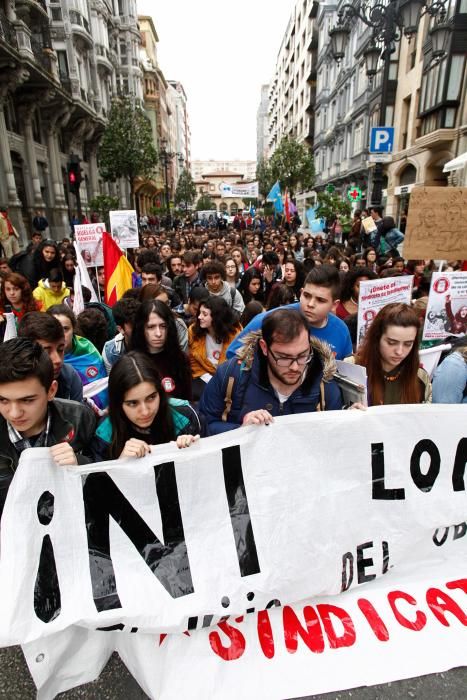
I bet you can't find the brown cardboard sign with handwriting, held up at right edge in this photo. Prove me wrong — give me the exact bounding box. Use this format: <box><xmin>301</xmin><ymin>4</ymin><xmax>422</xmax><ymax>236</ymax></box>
<box><xmin>402</xmin><ymin>187</ymin><xmax>467</xmax><ymax>260</ymax></box>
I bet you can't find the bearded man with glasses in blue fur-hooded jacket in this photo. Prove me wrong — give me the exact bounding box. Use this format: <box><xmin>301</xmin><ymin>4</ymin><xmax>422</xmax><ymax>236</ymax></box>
<box><xmin>199</xmin><ymin>308</ymin><xmax>342</xmax><ymax>435</ymax></box>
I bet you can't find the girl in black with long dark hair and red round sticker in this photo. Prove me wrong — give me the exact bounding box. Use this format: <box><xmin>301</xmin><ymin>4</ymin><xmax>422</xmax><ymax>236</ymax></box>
<box><xmin>130</xmin><ymin>300</ymin><xmax>191</xmax><ymax>401</ymax></box>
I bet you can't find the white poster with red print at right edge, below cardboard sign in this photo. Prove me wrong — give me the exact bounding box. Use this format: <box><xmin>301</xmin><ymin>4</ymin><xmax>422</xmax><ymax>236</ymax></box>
<box><xmin>423</xmin><ymin>272</ymin><xmax>467</xmax><ymax>340</ymax></box>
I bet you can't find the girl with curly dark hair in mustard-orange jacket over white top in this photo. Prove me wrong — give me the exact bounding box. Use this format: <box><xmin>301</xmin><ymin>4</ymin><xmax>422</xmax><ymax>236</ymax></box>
<box><xmin>188</xmin><ymin>296</ymin><xmax>243</xmax><ymax>400</ymax></box>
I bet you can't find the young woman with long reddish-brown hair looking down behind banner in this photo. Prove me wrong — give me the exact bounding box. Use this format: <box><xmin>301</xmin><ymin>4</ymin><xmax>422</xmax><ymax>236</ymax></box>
<box><xmin>351</xmin><ymin>303</ymin><xmax>431</xmax><ymax>406</ymax></box>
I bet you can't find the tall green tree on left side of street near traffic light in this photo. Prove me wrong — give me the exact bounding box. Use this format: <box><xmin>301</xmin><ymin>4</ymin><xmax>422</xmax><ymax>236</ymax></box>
<box><xmin>98</xmin><ymin>96</ymin><xmax>158</xmax><ymax>213</ymax></box>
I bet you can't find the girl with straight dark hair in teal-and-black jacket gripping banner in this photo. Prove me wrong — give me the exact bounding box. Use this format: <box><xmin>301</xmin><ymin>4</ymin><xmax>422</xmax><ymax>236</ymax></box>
<box><xmin>91</xmin><ymin>352</ymin><xmax>201</xmax><ymax>462</ymax></box>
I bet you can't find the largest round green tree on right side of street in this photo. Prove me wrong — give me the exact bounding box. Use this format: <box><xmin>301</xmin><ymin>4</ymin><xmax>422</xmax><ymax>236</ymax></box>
<box><xmin>269</xmin><ymin>136</ymin><xmax>315</xmax><ymax>196</ymax></box>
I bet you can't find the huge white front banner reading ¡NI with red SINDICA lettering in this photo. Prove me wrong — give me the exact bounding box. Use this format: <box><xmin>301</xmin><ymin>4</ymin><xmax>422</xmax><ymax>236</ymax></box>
<box><xmin>0</xmin><ymin>405</ymin><xmax>467</xmax><ymax>700</ymax></box>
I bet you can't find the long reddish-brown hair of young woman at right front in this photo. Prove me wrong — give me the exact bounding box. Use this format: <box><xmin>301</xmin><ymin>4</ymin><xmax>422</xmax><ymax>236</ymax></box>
<box><xmin>355</xmin><ymin>304</ymin><xmax>421</xmax><ymax>406</ymax></box>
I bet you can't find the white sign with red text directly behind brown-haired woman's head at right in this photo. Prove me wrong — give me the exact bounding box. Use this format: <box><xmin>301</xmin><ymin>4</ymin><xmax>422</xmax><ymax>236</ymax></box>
<box><xmin>357</xmin><ymin>275</ymin><xmax>413</xmax><ymax>345</ymax></box>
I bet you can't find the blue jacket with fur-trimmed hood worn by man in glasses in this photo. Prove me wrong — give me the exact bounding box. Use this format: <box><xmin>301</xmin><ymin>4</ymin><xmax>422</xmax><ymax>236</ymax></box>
<box><xmin>198</xmin><ymin>332</ymin><xmax>342</xmax><ymax>435</ymax></box>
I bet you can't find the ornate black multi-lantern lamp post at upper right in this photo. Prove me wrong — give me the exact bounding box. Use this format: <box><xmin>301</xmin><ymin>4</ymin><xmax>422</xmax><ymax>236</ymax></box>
<box><xmin>329</xmin><ymin>0</ymin><xmax>451</xmax><ymax>205</ymax></box>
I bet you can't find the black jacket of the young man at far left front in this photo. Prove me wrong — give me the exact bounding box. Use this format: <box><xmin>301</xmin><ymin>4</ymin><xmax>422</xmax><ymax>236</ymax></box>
<box><xmin>0</xmin><ymin>399</ymin><xmax>96</xmax><ymax>516</ymax></box>
